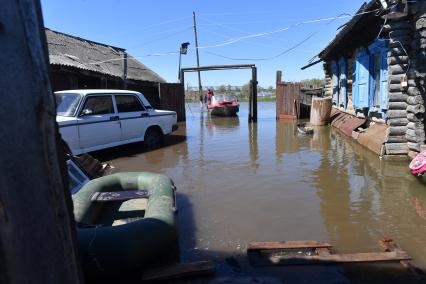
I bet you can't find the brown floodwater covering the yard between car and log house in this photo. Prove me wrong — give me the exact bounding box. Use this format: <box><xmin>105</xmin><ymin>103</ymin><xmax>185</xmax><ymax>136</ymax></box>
<box><xmin>95</xmin><ymin>103</ymin><xmax>426</xmax><ymax>283</ymax></box>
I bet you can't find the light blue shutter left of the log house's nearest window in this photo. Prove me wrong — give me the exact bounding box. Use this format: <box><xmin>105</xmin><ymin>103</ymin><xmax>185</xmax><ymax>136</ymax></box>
<box><xmin>357</xmin><ymin>49</ymin><xmax>370</xmax><ymax>108</ymax></box>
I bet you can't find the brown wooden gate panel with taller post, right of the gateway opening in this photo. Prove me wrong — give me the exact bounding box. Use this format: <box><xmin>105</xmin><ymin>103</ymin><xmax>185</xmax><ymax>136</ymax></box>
<box><xmin>276</xmin><ymin>71</ymin><xmax>300</xmax><ymax>119</ymax></box>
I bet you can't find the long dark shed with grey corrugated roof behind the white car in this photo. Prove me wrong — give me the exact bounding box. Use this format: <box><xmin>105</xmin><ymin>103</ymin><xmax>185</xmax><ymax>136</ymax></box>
<box><xmin>46</xmin><ymin>29</ymin><xmax>185</xmax><ymax>121</ymax></box>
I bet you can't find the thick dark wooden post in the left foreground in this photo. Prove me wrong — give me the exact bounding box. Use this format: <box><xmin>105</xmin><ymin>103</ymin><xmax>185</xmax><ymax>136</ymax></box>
<box><xmin>0</xmin><ymin>0</ymin><xmax>82</xmax><ymax>283</ymax></box>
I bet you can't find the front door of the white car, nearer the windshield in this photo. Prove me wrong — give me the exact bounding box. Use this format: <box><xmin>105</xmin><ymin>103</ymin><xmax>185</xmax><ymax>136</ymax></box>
<box><xmin>78</xmin><ymin>95</ymin><xmax>121</xmax><ymax>148</ymax></box>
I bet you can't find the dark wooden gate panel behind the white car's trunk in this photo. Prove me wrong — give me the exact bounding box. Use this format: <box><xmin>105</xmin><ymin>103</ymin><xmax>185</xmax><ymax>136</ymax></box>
<box><xmin>159</xmin><ymin>83</ymin><xmax>186</xmax><ymax>121</ymax></box>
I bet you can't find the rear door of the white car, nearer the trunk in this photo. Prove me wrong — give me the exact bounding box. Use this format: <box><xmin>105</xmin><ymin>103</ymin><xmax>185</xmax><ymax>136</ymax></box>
<box><xmin>115</xmin><ymin>94</ymin><xmax>149</xmax><ymax>141</ymax></box>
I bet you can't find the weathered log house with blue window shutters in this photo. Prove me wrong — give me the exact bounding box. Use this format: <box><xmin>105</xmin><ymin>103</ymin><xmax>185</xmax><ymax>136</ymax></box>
<box><xmin>304</xmin><ymin>0</ymin><xmax>426</xmax><ymax>155</ymax></box>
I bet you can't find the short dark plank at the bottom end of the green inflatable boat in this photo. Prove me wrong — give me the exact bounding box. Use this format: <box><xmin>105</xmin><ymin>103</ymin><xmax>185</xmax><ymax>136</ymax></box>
<box><xmin>142</xmin><ymin>261</ymin><xmax>215</xmax><ymax>281</ymax></box>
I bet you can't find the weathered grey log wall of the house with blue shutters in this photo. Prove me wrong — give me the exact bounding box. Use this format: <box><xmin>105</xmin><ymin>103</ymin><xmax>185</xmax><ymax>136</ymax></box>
<box><xmin>323</xmin><ymin>1</ymin><xmax>426</xmax><ymax>155</ymax></box>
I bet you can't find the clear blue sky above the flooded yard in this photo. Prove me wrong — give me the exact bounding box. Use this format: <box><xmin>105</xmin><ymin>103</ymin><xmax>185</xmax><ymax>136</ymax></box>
<box><xmin>41</xmin><ymin>0</ymin><xmax>364</xmax><ymax>87</ymax></box>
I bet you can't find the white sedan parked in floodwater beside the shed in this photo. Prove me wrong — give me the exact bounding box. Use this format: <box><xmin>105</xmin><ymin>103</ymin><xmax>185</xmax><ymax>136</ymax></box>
<box><xmin>55</xmin><ymin>90</ymin><xmax>177</xmax><ymax>155</ymax></box>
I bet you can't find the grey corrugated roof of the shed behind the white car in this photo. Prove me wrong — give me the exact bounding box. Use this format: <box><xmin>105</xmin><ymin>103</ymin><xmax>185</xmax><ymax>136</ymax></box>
<box><xmin>46</xmin><ymin>29</ymin><xmax>166</xmax><ymax>83</ymax></box>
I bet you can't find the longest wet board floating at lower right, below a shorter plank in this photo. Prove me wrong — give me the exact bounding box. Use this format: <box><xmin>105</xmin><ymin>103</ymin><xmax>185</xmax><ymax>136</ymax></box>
<box><xmin>250</xmin><ymin>251</ymin><xmax>411</xmax><ymax>266</ymax></box>
